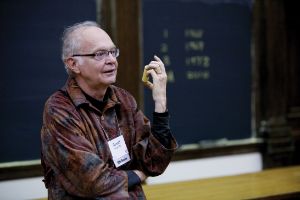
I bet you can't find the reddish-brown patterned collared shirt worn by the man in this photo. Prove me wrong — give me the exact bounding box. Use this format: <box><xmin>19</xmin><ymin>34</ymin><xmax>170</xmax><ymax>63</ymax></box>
<box><xmin>41</xmin><ymin>78</ymin><xmax>177</xmax><ymax>200</ymax></box>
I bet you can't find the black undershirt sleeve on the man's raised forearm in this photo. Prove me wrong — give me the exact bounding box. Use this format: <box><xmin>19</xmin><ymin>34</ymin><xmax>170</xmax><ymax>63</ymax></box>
<box><xmin>151</xmin><ymin>112</ymin><xmax>172</xmax><ymax>148</ymax></box>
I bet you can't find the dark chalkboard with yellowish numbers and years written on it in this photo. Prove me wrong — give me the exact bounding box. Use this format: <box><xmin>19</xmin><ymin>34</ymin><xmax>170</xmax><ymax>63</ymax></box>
<box><xmin>142</xmin><ymin>0</ymin><xmax>252</xmax><ymax>144</ymax></box>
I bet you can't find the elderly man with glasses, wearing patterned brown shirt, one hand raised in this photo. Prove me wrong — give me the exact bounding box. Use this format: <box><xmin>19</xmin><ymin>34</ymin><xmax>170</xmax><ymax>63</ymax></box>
<box><xmin>41</xmin><ymin>21</ymin><xmax>177</xmax><ymax>200</ymax></box>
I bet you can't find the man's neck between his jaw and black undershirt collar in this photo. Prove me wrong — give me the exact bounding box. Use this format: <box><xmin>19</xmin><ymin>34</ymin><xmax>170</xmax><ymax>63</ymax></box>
<box><xmin>75</xmin><ymin>78</ymin><xmax>108</xmax><ymax>101</ymax></box>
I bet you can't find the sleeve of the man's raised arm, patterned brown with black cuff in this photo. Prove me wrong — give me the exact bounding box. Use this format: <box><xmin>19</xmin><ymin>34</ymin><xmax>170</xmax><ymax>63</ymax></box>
<box><xmin>133</xmin><ymin>110</ymin><xmax>178</xmax><ymax>176</ymax></box>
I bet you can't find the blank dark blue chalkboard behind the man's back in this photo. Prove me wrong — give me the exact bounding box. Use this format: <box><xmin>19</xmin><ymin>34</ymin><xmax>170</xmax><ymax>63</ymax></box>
<box><xmin>0</xmin><ymin>0</ymin><xmax>96</xmax><ymax>162</ymax></box>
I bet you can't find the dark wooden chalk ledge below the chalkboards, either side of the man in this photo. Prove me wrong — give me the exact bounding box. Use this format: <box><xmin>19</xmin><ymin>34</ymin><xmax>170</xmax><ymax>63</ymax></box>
<box><xmin>0</xmin><ymin>138</ymin><xmax>263</xmax><ymax>181</ymax></box>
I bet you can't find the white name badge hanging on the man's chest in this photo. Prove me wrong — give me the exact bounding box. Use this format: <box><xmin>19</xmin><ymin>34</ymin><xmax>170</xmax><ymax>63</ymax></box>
<box><xmin>108</xmin><ymin>135</ymin><xmax>130</xmax><ymax>167</ymax></box>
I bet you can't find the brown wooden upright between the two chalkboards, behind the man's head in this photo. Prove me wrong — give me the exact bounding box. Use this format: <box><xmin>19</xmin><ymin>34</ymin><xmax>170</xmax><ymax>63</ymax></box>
<box><xmin>99</xmin><ymin>0</ymin><xmax>143</xmax><ymax>106</ymax></box>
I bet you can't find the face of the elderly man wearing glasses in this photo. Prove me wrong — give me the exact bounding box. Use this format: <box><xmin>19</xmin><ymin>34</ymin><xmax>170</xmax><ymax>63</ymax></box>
<box><xmin>69</xmin><ymin>27</ymin><xmax>118</xmax><ymax>89</ymax></box>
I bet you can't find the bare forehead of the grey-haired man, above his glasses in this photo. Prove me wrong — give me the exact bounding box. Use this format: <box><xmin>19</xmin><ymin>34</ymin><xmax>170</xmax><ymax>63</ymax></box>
<box><xmin>79</xmin><ymin>27</ymin><xmax>115</xmax><ymax>50</ymax></box>
